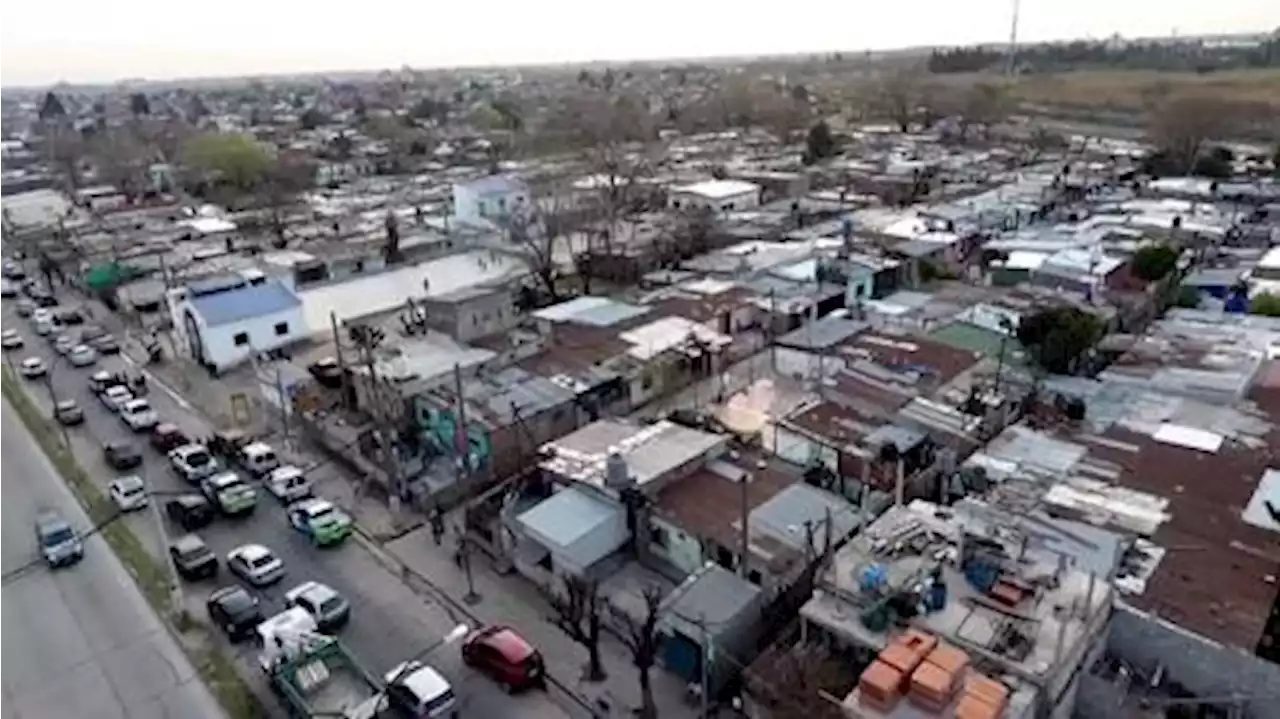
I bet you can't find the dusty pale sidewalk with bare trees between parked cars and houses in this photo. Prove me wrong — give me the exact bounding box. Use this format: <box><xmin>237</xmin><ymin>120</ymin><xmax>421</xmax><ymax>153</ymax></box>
<box><xmin>323</xmin><ymin>482</ymin><xmax>699</xmax><ymax>719</ymax></box>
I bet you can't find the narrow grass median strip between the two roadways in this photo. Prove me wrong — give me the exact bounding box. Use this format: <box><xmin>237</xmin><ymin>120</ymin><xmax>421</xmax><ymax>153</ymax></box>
<box><xmin>0</xmin><ymin>367</ymin><xmax>268</xmax><ymax>719</ymax></box>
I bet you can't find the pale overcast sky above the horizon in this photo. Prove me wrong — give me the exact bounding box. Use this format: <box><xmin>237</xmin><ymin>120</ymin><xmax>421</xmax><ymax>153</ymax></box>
<box><xmin>0</xmin><ymin>0</ymin><xmax>1280</xmax><ymax>86</ymax></box>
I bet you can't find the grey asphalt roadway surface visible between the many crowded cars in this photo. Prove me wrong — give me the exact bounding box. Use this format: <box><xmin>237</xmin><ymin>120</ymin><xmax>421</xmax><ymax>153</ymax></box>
<box><xmin>0</xmin><ymin>291</ymin><xmax>563</xmax><ymax>719</ymax></box>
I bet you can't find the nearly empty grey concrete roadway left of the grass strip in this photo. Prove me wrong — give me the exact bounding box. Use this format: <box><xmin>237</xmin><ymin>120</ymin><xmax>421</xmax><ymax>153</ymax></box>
<box><xmin>0</xmin><ymin>391</ymin><xmax>224</xmax><ymax>719</ymax></box>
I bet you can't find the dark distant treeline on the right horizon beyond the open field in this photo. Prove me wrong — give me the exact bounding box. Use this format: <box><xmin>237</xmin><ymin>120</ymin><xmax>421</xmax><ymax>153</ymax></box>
<box><xmin>929</xmin><ymin>37</ymin><xmax>1280</xmax><ymax>73</ymax></box>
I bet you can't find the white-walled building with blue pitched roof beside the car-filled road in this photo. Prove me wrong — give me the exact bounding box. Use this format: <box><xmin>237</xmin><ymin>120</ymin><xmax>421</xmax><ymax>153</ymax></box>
<box><xmin>166</xmin><ymin>273</ymin><xmax>311</xmax><ymax>372</ymax></box>
